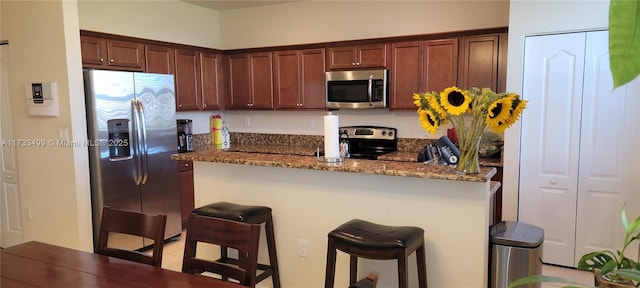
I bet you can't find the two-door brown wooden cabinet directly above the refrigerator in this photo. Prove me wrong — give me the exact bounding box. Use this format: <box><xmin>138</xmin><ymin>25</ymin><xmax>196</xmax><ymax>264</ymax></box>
<box><xmin>80</xmin><ymin>36</ymin><xmax>145</xmax><ymax>71</ymax></box>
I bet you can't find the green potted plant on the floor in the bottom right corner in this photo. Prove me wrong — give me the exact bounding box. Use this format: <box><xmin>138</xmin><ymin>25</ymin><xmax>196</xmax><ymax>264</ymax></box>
<box><xmin>509</xmin><ymin>208</ymin><xmax>640</xmax><ymax>288</ymax></box>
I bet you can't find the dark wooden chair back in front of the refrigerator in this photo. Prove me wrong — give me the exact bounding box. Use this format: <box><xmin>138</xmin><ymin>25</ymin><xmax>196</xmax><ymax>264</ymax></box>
<box><xmin>96</xmin><ymin>207</ymin><xmax>167</xmax><ymax>267</ymax></box>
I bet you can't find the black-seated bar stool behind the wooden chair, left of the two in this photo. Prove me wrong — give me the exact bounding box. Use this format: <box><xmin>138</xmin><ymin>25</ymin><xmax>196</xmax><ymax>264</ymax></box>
<box><xmin>191</xmin><ymin>202</ymin><xmax>280</xmax><ymax>288</ymax></box>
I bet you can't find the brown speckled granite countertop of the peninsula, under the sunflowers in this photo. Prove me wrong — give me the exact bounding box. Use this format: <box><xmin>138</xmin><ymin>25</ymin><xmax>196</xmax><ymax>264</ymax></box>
<box><xmin>171</xmin><ymin>145</ymin><xmax>497</xmax><ymax>182</ymax></box>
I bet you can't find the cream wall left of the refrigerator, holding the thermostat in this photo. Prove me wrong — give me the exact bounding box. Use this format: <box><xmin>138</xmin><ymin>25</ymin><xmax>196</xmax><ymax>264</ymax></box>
<box><xmin>0</xmin><ymin>1</ymin><xmax>93</xmax><ymax>250</ymax></box>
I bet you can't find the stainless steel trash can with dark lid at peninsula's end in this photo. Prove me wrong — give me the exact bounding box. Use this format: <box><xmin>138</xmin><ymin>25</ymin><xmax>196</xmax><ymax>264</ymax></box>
<box><xmin>489</xmin><ymin>221</ymin><xmax>544</xmax><ymax>288</ymax></box>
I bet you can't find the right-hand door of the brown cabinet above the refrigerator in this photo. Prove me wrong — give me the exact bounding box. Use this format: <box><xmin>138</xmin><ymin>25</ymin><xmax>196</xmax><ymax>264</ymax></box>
<box><xmin>107</xmin><ymin>40</ymin><xmax>145</xmax><ymax>71</ymax></box>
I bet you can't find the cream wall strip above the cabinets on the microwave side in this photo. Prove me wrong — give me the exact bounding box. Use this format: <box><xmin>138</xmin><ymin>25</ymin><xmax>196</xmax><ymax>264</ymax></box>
<box><xmin>220</xmin><ymin>0</ymin><xmax>509</xmax><ymax>49</ymax></box>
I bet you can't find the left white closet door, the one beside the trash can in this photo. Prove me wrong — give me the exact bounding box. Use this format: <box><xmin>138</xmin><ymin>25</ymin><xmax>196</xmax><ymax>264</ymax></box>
<box><xmin>518</xmin><ymin>33</ymin><xmax>585</xmax><ymax>266</ymax></box>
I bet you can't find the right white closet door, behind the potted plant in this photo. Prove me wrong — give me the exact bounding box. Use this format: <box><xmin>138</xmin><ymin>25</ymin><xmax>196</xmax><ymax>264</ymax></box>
<box><xmin>576</xmin><ymin>31</ymin><xmax>640</xmax><ymax>263</ymax></box>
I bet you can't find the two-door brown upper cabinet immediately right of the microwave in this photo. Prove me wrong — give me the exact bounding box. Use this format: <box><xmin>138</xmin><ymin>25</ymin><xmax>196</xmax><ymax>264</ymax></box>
<box><xmin>389</xmin><ymin>39</ymin><xmax>458</xmax><ymax>109</ymax></box>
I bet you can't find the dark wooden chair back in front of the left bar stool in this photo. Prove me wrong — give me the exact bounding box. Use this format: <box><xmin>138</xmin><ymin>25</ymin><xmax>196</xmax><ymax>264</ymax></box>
<box><xmin>182</xmin><ymin>213</ymin><xmax>260</xmax><ymax>287</ymax></box>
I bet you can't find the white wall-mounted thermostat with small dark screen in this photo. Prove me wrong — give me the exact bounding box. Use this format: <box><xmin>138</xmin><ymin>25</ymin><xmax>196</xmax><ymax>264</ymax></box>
<box><xmin>25</xmin><ymin>82</ymin><xmax>60</xmax><ymax>117</ymax></box>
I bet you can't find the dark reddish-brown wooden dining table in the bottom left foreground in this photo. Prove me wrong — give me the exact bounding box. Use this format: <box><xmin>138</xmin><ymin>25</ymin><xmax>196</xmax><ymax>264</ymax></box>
<box><xmin>0</xmin><ymin>241</ymin><xmax>246</xmax><ymax>288</ymax></box>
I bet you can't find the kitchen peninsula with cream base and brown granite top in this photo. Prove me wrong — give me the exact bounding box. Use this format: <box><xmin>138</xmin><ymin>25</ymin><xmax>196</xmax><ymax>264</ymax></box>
<box><xmin>173</xmin><ymin>147</ymin><xmax>499</xmax><ymax>287</ymax></box>
